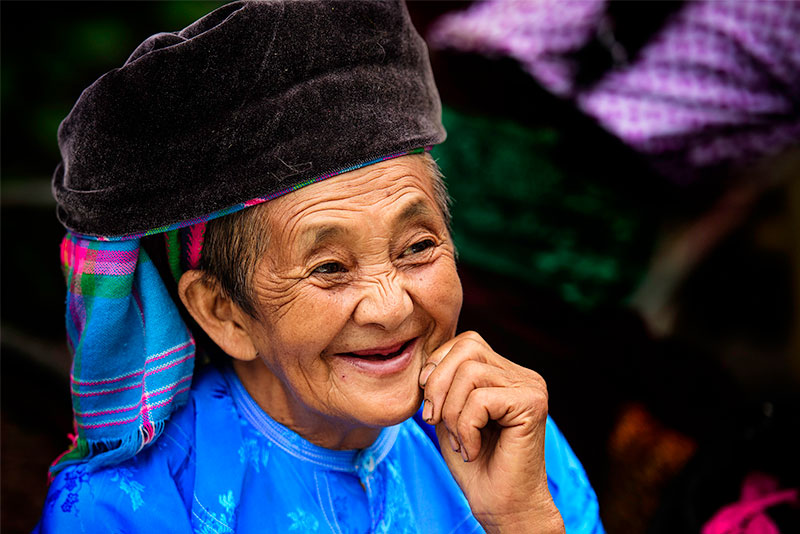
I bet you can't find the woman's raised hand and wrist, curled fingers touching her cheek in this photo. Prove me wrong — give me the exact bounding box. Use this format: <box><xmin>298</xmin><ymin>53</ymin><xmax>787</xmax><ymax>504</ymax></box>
<box><xmin>420</xmin><ymin>332</ymin><xmax>564</xmax><ymax>534</ymax></box>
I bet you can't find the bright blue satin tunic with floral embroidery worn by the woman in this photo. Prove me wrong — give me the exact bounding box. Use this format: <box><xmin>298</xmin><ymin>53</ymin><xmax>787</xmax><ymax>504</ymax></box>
<box><xmin>34</xmin><ymin>368</ymin><xmax>604</xmax><ymax>534</ymax></box>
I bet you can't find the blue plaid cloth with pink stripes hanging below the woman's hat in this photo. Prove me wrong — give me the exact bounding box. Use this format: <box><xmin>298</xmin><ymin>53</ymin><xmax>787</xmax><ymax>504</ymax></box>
<box><xmin>51</xmin><ymin>234</ymin><xmax>195</xmax><ymax>473</ymax></box>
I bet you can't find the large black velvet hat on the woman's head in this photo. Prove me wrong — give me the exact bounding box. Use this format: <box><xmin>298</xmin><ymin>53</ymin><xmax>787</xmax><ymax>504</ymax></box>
<box><xmin>53</xmin><ymin>0</ymin><xmax>445</xmax><ymax>237</ymax></box>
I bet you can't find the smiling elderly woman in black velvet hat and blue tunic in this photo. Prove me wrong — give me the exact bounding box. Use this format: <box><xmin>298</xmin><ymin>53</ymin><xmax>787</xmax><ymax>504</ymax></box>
<box><xmin>37</xmin><ymin>1</ymin><xmax>602</xmax><ymax>533</ymax></box>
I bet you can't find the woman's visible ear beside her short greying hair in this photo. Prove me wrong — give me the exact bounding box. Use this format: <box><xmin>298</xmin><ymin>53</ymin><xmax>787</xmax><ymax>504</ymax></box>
<box><xmin>178</xmin><ymin>270</ymin><xmax>258</xmax><ymax>361</ymax></box>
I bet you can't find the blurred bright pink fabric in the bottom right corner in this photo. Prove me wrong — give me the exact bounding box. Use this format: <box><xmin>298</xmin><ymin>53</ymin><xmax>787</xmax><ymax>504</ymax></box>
<box><xmin>702</xmin><ymin>472</ymin><xmax>800</xmax><ymax>534</ymax></box>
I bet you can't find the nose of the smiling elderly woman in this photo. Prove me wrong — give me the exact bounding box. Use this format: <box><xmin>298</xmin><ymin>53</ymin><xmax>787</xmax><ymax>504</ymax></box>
<box><xmin>353</xmin><ymin>271</ymin><xmax>414</xmax><ymax>331</ymax></box>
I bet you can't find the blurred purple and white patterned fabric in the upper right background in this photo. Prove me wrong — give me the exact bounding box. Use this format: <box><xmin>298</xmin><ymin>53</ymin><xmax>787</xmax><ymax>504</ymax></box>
<box><xmin>430</xmin><ymin>0</ymin><xmax>800</xmax><ymax>182</ymax></box>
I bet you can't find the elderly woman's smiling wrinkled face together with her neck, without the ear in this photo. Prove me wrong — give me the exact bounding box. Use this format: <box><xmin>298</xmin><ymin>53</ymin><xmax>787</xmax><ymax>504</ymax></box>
<box><xmin>237</xmin><ymin>156</ymin><xmax>461</xmax><ymax>448</ymax></box>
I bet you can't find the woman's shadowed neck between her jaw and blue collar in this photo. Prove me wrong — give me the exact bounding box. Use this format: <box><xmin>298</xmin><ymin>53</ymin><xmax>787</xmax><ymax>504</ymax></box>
<box><xmin>233</xmin><ymin>359</ymin><xmax>382</xmax><ymax>450</ymax></box>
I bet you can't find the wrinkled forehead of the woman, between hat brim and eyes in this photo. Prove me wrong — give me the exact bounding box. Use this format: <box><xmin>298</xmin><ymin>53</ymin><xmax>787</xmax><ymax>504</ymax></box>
<box><xmin>266</xmin><ymin>155</ymin><xmax>443</xmax><ymax>237</ymax></box>
